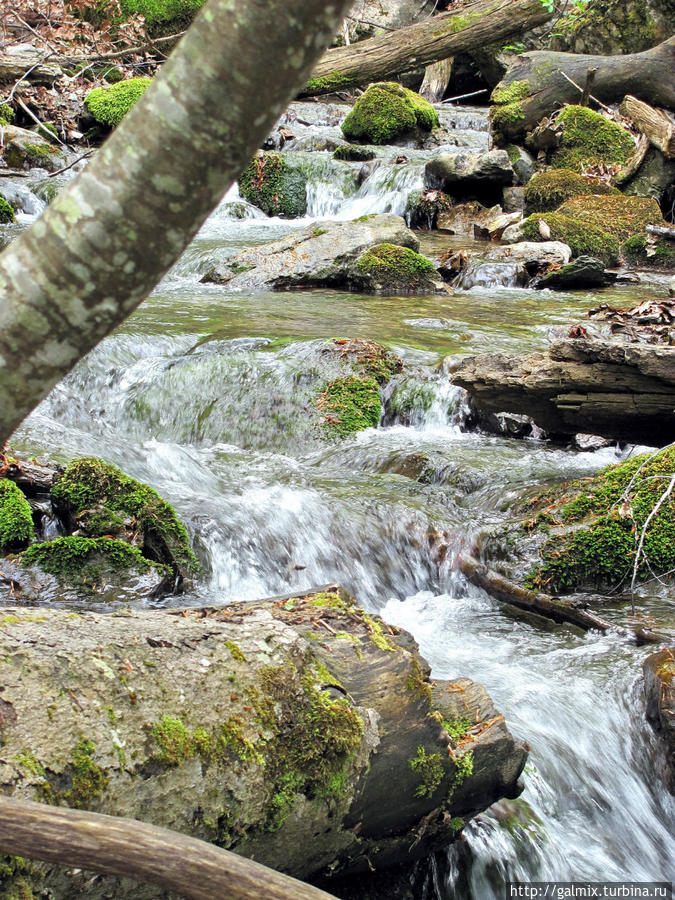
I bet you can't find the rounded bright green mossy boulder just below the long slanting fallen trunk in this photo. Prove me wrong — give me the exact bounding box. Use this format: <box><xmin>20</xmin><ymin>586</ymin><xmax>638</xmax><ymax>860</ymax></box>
<box><xmin>342</xmin><ymin>81</ymin><xmax>438</xmax><ymax>144</ymax></box>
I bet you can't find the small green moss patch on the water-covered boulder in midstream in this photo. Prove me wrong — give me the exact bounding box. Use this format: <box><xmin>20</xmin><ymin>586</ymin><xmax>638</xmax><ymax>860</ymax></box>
<box><xmin>316</xmin><ymin>375</ymin><xmax>382</xmax><ymax>437</ymax></box>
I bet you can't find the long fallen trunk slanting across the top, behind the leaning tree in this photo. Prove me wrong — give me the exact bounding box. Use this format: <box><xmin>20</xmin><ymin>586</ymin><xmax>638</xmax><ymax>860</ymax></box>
<box><xmin>301</xmin><ymin>0</ymin><xmax>551</xmax><ymax>96</ymax></box>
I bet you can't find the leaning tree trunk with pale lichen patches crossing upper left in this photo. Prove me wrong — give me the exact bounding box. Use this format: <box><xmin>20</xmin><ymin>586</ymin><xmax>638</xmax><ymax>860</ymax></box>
<box><xmin>0</xmin><ymin>0</ymin><xmax>349</xmax><ymax>442</ymax></box>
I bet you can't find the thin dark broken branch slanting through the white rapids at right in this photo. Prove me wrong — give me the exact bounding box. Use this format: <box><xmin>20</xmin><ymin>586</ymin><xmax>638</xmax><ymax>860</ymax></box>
<box><xmin>457</xmin><ymin>554</ymin><xmax>662</xmax><ymax>644</ymax></box>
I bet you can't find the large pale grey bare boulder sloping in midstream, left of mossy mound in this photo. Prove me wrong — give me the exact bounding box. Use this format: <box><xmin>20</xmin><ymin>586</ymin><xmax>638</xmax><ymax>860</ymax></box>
<box><xmin>202</xmin><ymin>213</ymin><xmax>419</xmax><ymax>291</ymax></box>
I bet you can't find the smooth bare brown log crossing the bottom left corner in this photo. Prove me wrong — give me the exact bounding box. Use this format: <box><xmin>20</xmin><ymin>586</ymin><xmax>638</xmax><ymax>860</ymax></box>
<box><xmin>0</xmin><ymin>796</ymin><xmax>335</xmax><ymax>900</ymax></box>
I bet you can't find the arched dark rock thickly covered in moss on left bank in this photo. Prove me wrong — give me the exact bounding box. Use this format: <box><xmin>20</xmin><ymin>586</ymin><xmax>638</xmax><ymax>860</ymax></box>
<box><xmin>51</xmin><ymin>458</ymin><xmax>197</xmax><ymax>576</ymax></box>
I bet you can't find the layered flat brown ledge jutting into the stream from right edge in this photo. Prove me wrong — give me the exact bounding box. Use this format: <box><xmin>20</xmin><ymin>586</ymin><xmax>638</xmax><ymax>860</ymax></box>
<box><xmin>449</xmin><ymin>340</ymin><xmax>675</xmax><ymax>447</ymax></box>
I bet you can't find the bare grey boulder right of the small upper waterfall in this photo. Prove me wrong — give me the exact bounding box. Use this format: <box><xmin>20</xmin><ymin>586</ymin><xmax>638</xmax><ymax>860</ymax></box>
<box><xmin>424</xmin><ymin>150</ymin><xmax>515</xmax><ymax>194</ymax></box>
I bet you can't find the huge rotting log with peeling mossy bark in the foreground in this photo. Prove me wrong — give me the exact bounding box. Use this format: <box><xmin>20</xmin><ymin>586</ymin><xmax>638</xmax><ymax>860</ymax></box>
<box><xmin>0</xmin><ymin>585</ymin><xmax>527</xmax><ymax>900</ymax></box>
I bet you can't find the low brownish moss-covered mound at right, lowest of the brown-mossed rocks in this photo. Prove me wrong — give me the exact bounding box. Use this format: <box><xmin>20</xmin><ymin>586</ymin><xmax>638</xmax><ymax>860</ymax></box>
<box><xmin>558</xmin><ymin>193</ymin><xmax>668</xmax><ymax>241</ymax></box>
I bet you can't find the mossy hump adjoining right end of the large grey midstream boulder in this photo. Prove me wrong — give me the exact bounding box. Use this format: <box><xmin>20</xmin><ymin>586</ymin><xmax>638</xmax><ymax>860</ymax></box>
<box><xmin>354</xmin><ymin>244</ymin><xmax>438</xmax><ymax>293</ymax></box>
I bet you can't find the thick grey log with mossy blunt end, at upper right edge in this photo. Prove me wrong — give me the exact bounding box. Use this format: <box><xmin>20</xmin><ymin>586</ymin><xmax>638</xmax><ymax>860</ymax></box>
<box><xmin>491</xmin><ymin>37</ymin><xmax>675</xmax><ymax>146</ymax></box>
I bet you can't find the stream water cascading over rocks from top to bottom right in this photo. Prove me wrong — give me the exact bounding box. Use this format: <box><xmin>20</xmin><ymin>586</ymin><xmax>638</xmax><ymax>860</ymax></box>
<box><xmin>5</xmin><ymin>103</ymin><xmax>675</xmax><ymax>900</ymax></box>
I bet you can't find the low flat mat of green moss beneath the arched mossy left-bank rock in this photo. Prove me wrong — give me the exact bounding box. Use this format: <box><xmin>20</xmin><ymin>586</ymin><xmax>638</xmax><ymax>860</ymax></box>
<box><xmin>21</xmin><ymin>537</ymin><xmax>169</xmax><ymax>590</ymax></box>
